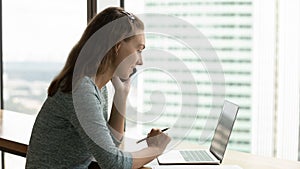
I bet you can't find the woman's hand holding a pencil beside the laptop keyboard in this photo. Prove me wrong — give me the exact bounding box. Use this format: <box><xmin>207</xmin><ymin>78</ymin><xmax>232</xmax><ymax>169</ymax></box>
<box><xmin>147</xmin><ymin>129</ymin><xmax>171</xmax><ymax>154</ymax></box>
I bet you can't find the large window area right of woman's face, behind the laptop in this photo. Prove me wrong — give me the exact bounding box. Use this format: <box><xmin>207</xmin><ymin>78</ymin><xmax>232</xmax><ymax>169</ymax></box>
<box><xmin>125</xmin><ymin>0</ymin><xmax>300</xmax><ymax>160</ymax></box>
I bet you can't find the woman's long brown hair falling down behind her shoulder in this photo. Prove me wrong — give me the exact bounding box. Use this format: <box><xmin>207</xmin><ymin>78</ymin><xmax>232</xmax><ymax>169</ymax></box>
<box><xmin>48</xmin><ymin>7</ymin><xmax>144</xmax><ymax>96</ymax></box>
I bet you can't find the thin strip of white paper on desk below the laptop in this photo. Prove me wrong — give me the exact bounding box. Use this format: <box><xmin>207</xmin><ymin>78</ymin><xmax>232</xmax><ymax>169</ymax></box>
<box><xmin>152</xmin><ymin>165</ymin><xmax>242</xmax><ymax>169</ymax></box>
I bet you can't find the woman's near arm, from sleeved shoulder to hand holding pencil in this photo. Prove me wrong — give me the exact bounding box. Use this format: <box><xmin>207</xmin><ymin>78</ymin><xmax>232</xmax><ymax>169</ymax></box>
<box><xmin>70</xmin><ymin>78</ymin><xmax>170</xmax><ymax>169</ymax></box>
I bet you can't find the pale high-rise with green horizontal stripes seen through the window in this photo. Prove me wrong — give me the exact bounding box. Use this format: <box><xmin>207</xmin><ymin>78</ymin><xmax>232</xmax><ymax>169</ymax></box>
<box><xmin>125</xmin><ymin>0</ymin><xmax>253</xmax><ymax>152</ymax></box>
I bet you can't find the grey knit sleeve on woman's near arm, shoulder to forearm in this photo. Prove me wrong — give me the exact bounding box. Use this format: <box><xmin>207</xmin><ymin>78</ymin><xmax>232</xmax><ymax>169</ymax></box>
<box><xmin>71</xmin><ymin>78</ymin><xmax>132</xmax><ymax>169</ymax></box>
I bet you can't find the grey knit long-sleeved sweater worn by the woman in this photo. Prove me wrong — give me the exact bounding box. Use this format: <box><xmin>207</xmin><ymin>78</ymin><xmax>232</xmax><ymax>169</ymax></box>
<box><xmin>26</xmin><ymin>77</ymin><xmax>132</xmax><ymax>169</ymax></box>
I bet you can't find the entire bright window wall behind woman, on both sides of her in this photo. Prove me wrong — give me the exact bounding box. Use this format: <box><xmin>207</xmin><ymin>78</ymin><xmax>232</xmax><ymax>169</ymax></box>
<box><xmin>2</xmin><ymin>0</ymin><xmax>300</xmax><ymax>166</ymax></box>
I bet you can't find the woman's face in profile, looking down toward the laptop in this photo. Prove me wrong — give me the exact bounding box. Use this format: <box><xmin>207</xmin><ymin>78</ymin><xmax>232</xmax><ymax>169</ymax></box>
<box><xmin>114</xmin><ymin>34</ymin><xmax>145</xmax><ymax>79</ymax></box>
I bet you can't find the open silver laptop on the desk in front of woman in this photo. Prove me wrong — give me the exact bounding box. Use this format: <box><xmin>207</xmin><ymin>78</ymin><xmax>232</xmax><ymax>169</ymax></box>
<box><xmin>157</xmin><ymin>100</ymin><xmax>239</xmax><ymax>165</ymax></box>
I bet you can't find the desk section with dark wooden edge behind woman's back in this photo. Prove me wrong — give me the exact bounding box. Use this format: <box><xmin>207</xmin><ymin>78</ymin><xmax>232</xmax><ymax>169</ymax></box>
<box><xmin>0</xmin><ymin>110</ymin><xmax>36</xmax><ymax>168</ymax></box>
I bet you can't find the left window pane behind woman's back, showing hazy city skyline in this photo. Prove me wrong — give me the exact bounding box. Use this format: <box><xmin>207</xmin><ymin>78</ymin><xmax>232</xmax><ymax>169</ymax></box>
<box><xmin>2</xmin><ymin>0</ymin><xmax>87</xmax><ymax>114</ymax></box>
